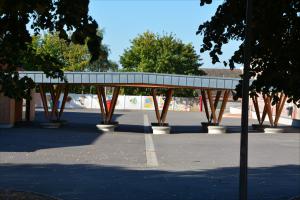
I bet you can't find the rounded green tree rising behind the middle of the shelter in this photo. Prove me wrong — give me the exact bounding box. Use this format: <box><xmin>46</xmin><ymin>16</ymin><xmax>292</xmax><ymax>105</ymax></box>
<box><xmin>120</xmin><ymin>32</ymin><xmax>205</xmax><ymax>96</ymax></box>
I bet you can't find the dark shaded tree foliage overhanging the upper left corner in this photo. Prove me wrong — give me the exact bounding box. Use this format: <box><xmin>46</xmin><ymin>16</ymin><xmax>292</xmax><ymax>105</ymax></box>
<box><xmin>0</xmin><ymin>0</ymin><xmax>102</xmax><ymax>98</ymax></box>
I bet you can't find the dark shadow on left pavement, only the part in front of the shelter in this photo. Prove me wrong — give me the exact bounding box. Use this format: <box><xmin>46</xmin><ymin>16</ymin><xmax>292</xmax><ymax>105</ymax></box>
<box><xmin>0</xmin><ymin>127</ymin><xmax>101</xmax><ymax>152</ymax></box>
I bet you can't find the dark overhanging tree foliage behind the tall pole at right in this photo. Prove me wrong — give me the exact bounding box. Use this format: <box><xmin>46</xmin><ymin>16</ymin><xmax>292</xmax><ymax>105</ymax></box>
<box><xmin>197</xmin><ymin>0</ymin><xmax>300</xmax><ymax>106</ymax></box>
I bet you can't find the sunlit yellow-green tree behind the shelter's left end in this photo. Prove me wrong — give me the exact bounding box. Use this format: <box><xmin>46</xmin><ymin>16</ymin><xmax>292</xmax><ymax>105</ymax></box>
<box><xmin>24</xmin><ymin>31</ymin><xmax>118</xmax><ymax>71</ymax></box>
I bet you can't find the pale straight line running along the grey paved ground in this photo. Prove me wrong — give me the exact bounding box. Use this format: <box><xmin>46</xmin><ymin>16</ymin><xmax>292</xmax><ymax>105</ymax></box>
<box><xmin>144</xmin><ymin>114</ymin><xmax>158</xmax><ymax>167</ymax></box>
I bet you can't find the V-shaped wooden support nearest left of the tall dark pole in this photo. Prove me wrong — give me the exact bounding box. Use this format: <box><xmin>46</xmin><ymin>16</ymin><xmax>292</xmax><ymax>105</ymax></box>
<box><xmin>201</xmin><ymin>90</ymin><xmax>230</xmax><ymax>124</ymax></box>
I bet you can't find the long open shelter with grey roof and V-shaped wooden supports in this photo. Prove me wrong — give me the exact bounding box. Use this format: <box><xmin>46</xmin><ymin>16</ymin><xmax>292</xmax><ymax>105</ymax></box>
<box><xmin>20</xmin><ymin>71</ymin><xmax>240</xmax><ymax>130</ymax></box>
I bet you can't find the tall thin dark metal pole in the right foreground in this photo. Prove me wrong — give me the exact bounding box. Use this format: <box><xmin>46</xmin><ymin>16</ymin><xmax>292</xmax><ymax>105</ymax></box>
<box><xmin>239</xmin><ymin>0</ymin><xmax>252</xmax><ymax>200</ymax></box>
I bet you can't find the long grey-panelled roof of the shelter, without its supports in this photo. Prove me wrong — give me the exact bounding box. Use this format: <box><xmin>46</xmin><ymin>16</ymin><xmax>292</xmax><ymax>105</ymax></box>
<box><xmin>19</xmin><ymin>71</ymin><xmax>240</xmax><ymax>90</ymax></box>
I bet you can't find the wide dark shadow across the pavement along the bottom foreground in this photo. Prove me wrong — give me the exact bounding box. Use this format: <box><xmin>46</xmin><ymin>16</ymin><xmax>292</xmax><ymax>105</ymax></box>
<box><xmin>0</xmin><ymin>164</ymin><xmax>300</xmax><ymax>200</ymax></box>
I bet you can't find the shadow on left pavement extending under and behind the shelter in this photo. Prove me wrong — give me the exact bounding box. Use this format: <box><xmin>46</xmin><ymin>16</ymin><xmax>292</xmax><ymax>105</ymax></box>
<box><xmin>0</xmin><ymin>112</ymin><xmax>125</xmax><ymax>152</ymax></box>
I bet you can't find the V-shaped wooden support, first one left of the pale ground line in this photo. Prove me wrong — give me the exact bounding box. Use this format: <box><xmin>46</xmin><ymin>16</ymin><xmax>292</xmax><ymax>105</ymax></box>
<box><xmin>96</xmin><ymin>86</ymin><xmax>120</xmax><ymax>124</ymax></box>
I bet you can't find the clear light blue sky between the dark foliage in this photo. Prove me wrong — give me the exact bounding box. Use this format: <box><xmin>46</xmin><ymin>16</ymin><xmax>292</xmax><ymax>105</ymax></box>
<box><xmin>89</xmin><ymin>0</ymin><xmax>238</xmax><ymax>68</ymax></box>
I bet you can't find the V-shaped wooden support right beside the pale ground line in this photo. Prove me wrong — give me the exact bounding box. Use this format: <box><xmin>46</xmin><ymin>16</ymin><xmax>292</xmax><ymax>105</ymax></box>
<box><xmin>151</xmin><ymin>88</ymin><xmax>174</xmax><ymax>125</ymax></box>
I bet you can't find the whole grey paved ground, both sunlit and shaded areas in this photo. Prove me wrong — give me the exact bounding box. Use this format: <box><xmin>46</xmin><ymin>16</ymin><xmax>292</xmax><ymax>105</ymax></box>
<box><xmin>0</xmin><ymin>111</ymin><xmax>300</xmax><ymax>200</ymax></box>
